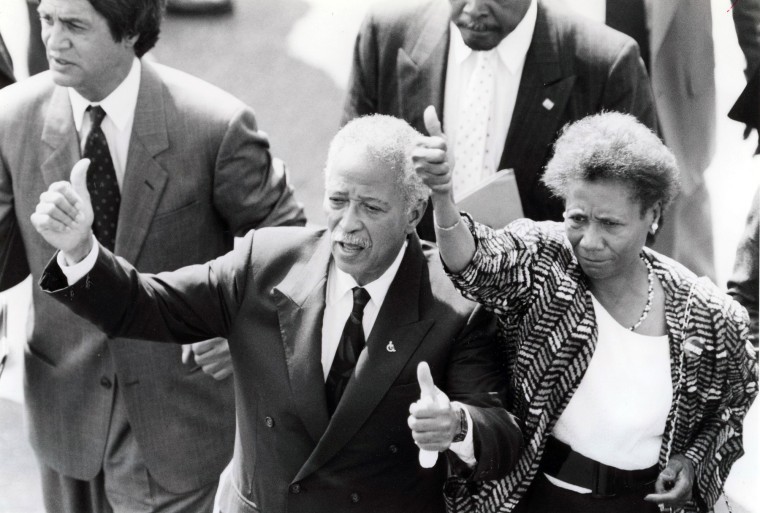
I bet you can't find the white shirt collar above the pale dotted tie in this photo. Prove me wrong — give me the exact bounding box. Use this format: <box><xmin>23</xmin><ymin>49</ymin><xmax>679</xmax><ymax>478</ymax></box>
<box><xmin>449</xmin><ymin>0</ymin><xmax>538</xmax><ymax>74</ymax></box>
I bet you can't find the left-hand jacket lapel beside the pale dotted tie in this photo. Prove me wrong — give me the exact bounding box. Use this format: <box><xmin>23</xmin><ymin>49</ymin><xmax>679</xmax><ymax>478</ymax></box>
<box><xmin>396</xmin><ymin>2</ymin><xmax>449</xmax><ymax>131</ymax></box>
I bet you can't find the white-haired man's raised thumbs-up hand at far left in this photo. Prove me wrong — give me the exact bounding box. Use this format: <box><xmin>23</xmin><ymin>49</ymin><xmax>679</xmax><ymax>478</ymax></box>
<box><xmin>30</xmin><ymin>159</ymin><xmax>93</xmax><ymax>264</ymax></box>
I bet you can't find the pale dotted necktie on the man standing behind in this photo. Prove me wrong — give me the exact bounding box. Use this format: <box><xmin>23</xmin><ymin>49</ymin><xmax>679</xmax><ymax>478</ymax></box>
<box><xmin>453</xmin><ymin>50</ymin><xmax>497</xmax><ymax>196</ymax></box>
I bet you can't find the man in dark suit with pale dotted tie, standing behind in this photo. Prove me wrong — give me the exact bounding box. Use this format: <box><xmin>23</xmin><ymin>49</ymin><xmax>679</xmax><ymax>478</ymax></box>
<box><xmin>343</xmin><ymin>0</ymin><xmax>656</xmax><ymax>238</ymax></box>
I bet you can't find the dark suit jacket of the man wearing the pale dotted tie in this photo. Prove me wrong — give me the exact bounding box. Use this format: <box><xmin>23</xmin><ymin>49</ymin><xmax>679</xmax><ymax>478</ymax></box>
<box><xmin>343</xmin><ymin>0</ymin><xmax>656</xmax><ymax>238</ymax></box>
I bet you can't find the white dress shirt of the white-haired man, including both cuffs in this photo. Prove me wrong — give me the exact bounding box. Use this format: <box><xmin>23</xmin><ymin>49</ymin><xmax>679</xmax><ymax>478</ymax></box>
<box><xmin>56</xmin><ymin>235</ymin><xmax>477</xmax><ymax>468</ymax></box>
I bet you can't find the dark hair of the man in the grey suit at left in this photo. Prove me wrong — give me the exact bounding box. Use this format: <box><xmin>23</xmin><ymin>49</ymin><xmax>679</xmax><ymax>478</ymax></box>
<box><xmin>88</xmin><ymin>0</ymin><xmax>166</xmax><ymax>57</ymax></box>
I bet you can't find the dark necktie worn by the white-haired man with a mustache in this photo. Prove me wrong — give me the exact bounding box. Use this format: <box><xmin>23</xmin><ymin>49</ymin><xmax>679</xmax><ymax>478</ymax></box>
<box><xmin>325</xmin><ymin>287</ymin><xmax>370</xmax><ymax>417</ymax></box>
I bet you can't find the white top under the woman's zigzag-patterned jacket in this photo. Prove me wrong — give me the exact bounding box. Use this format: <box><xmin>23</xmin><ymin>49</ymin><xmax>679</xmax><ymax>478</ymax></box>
<box><xmin>547</xmin><ymin>296</ymin><xmax>673</xmax><ymax>493</ymax></box>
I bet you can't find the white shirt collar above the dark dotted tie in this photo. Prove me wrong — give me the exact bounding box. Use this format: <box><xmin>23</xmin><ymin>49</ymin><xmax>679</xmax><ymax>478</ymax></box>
<box><xmin>68</xmin><ymin>57</ymin><xmax>142</xmax><ymax>132</ymax></box>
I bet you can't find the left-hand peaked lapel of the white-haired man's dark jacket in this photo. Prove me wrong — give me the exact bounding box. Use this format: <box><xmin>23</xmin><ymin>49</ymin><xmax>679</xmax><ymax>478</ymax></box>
<box><xmin>273</xmin><ymin>232</ymin><xmax>330</xmax><ymax>444</ymax></box>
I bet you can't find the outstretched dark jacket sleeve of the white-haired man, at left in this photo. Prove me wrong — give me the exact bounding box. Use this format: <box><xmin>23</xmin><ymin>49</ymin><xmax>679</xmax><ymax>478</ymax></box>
<box><xmin>40</xmin><ymin>232</ymin><xmax>254</xmax><ymax>343</ymax></box>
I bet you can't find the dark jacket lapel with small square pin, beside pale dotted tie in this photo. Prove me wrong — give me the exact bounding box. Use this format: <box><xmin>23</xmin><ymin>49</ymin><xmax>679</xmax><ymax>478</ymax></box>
<box><xmin>499</xmin><ymin>3</ymin><xmax>575</xmax><ymax>191</ymax></box>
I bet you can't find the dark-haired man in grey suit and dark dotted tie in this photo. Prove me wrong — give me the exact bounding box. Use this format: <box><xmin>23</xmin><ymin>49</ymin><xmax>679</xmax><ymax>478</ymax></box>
<box><xmin>0</xmin><ymin>0</ymin><xmax>304</xmax><ymax>513</ymax></box>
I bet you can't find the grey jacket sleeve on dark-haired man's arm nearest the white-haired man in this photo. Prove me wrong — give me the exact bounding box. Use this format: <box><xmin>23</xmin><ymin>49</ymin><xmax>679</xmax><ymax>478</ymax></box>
<box><xmin>214</xmin><ymin>107</ymin><xmax>306</xmax><ymax>236</ymax></box>
